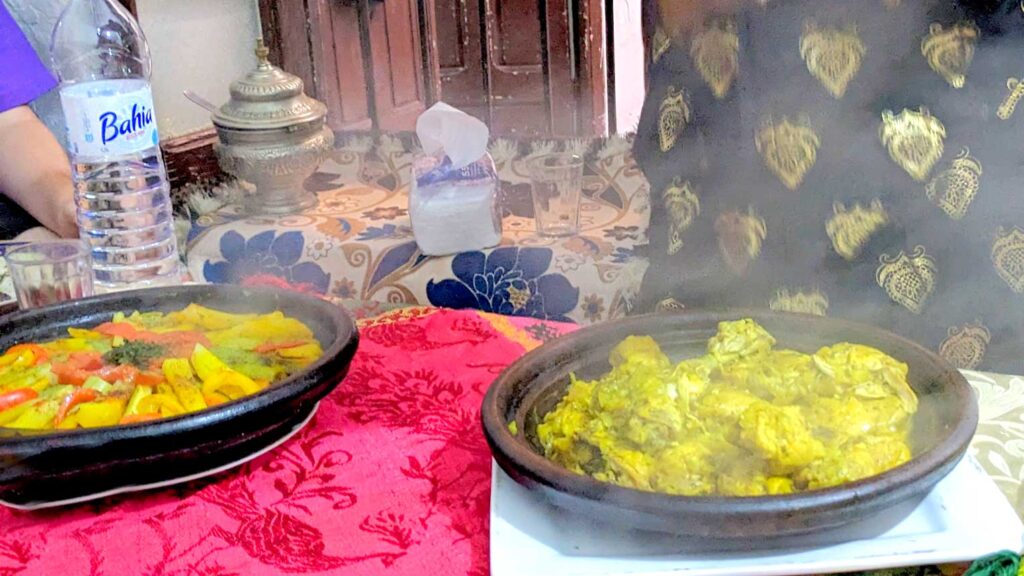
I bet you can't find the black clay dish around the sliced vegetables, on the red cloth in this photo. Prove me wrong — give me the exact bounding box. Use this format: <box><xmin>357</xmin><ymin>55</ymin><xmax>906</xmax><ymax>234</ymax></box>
<box><xmin>0</xmin><ymin>285</ymin><xmax>358</xmax><ymax>508</ymax></box>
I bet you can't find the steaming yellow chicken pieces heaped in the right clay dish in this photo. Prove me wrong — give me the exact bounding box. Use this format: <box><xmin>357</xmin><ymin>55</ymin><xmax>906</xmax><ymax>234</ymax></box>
<box><xmin>537</xmin><ymin>320</ymin><xmax>918</xmax><ymax>496</ymax></box>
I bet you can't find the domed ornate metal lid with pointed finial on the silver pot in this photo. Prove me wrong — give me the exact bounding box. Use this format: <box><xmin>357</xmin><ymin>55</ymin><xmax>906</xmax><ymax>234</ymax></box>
<box><xmin>213</xmin><ymin>39</ymin><xmax>327</xmax><ymax>130</ymax></box>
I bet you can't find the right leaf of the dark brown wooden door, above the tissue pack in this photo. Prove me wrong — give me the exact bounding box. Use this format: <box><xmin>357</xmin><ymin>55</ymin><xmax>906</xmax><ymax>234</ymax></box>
<box><xmin>435</xmin><ymin>0</ymin><xmax>605</xmax><ymax>136</ymax></box>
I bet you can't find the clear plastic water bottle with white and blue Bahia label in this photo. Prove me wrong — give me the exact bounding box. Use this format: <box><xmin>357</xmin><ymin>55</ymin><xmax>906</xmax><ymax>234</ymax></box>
<box><xmin>50</xmin><ymin>0</ymin><xmax>181</xmax><ymax>291</ymax></box>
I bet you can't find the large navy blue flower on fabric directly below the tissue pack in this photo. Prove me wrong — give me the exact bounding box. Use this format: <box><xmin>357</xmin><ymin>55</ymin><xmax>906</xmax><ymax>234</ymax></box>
<box><xmin>427</xmin><ymin>243</ymin><xmax>580</xmax><ymax>322</ymax></box>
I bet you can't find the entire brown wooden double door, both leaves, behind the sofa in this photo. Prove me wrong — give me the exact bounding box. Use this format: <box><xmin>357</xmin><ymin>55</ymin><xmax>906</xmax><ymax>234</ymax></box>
<box><xmin>259</xmin><ymin>0</ymin><xmax>607</xmax><ymax>136</ymax></box>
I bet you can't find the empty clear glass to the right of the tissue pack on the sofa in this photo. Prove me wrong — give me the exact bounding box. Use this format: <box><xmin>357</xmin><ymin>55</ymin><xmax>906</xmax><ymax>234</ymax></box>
<box><xmin>527</xmin><ymin>154</ymin><xmax>583</xmax><ymax>237</ymax></box>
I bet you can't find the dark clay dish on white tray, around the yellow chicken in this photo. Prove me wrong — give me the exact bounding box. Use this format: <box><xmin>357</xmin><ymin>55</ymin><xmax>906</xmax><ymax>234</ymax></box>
<box><xmin>482</xmin><ymin>311</ymin><xmax>978</xmax><ymax>537</ymax></box>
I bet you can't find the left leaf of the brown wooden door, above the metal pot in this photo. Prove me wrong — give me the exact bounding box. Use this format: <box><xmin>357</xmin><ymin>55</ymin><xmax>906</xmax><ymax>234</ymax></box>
<box><xmin>260</xmin><ymin>0</ymin><xmax>436</xmax><ymax>131</ymax></box>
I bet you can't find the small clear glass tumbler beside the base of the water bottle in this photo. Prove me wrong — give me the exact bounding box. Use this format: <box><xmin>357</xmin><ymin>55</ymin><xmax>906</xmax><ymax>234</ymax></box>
<box><xmin>4</xmin><ymin>240</ymin><xmax>93</xmax><ymax>310</ymax></box>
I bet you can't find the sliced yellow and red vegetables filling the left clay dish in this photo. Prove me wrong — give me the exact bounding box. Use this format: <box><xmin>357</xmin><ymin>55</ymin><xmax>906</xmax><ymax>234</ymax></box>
<box><xmin>0</xmin><ymin>304</ymin><xmax>323</xmax><ymax>430</ymax></box>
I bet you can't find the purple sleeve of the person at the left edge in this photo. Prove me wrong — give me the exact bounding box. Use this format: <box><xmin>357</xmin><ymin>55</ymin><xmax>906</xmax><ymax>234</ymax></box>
<box><xmin>0</xmin><ymin>2</ymin><xmax>56</xmax><ymax>112</ymax></box>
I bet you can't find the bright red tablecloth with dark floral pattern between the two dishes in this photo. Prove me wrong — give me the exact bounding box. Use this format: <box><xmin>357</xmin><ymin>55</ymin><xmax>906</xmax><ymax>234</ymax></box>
<box><xmin>0</xmin><ymin>308</ymin><xmax>571</xmax><ymax>576</ymax></box>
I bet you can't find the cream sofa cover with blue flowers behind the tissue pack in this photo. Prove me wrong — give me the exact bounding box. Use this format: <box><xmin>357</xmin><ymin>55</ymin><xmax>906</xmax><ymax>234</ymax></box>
<box><xmin>187</xmin><ymin>132</ymin><xmax>650</xmax><ymax>323</ymax></box>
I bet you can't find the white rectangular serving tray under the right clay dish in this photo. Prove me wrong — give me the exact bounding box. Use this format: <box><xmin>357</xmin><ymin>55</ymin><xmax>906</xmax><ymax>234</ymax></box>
<box><xmin>490</xmin><ymin>457</ymin><xmax>1024</xmax><ymax>576</ymax></box>
